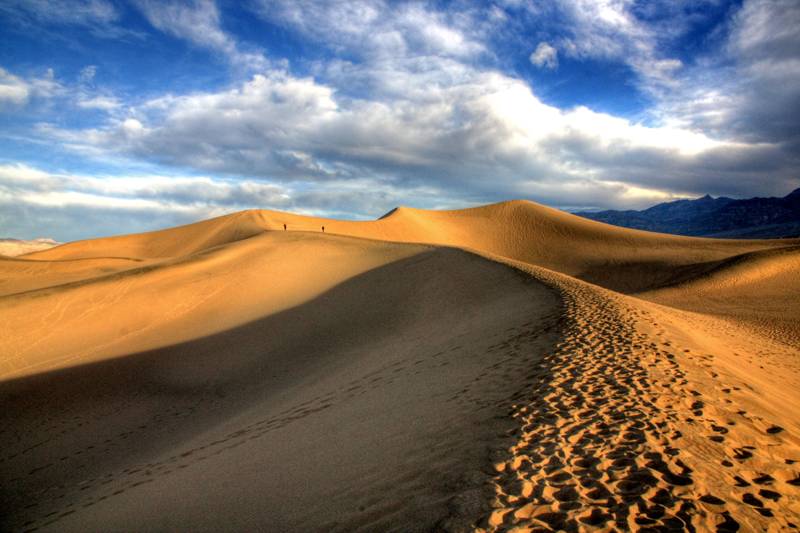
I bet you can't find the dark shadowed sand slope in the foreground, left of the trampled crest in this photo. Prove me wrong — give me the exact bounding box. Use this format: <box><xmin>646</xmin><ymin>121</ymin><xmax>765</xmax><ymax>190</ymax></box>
<box><xmin>0</xmin><ymin>243</ymin><xmax>559</xmax><ymax>531</ymax></box>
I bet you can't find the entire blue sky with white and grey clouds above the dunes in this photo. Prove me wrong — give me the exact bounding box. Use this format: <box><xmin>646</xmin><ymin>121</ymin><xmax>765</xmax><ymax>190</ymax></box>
<box><xmin>0</xmin><ymin>0</ymin><xmax>800</xmax><ymax>241</ymax></box>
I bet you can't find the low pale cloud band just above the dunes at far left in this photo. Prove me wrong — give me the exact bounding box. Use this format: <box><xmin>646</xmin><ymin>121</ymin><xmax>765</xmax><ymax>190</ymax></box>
<box><xmin>0</xmin><ymin>163</ymin><xmax>287</xmax><ymax>240</ymax></box>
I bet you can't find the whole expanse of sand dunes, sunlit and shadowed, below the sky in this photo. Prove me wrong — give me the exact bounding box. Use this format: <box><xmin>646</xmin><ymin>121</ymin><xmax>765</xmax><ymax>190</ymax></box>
<box><xmin>0</xmin><ymin>201</ymin><xmax>800</xmax><ymax>532</ymax></box>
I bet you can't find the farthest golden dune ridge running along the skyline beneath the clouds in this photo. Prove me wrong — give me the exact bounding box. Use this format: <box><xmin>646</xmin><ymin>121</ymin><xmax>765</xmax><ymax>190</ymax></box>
<box><xmin>27</xmin><ymin>201</ymin><xmax>800</xmax><ymax>292</ymax></box>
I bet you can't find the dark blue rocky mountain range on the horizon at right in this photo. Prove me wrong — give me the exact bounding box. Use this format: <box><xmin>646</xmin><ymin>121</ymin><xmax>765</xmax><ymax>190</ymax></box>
<box><xmin>575</xmin><ymin>189</ymin><xmax>800</xmax><ymax>239</ymax></box>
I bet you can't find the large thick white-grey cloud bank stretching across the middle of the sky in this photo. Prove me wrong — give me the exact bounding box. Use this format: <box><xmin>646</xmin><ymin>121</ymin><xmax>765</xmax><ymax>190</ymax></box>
<box><xmin>42</xmin><ymin>63</ymin><xmax>796</xmax><ymax>216</ymax></box>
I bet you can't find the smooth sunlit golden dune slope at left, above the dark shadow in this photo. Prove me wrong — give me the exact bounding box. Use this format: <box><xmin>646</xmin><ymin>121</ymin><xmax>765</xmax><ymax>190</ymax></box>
<box><xmin>0</xmin><ymin>233</ymin><xmax>432</xmax><ymax>377</ymax></box>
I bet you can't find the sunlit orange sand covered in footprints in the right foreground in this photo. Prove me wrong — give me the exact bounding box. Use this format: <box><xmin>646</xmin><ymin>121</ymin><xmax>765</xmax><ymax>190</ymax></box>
<box><xmin>480</xmin><ymin>264</ymin><xmax>800</xmax><ymax>531</ymax></box>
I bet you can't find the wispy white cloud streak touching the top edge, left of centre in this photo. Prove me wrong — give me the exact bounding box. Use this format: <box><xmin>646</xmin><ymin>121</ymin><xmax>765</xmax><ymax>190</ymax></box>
<box><xmin>137</xmin><ymin>0</ymin><xmax>267</xmax><ymax>70</ymax></box>
